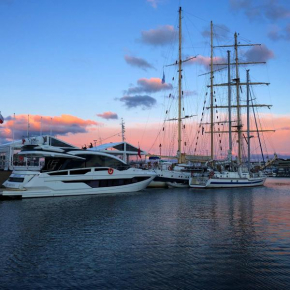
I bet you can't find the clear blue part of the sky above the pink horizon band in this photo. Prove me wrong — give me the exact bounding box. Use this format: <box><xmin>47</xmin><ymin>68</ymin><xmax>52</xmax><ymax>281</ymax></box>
<box><xmin>0</xmin><ymin>0</ymin><xmax>290</xmax><ymax>154</ymax></box>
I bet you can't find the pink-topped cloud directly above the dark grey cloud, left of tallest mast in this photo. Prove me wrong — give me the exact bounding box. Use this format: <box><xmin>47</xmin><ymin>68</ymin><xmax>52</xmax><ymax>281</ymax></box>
<box><xmin>127</xmin><ymin>78</ymin><xmax>172</xmax><ymax>95</ymax></box>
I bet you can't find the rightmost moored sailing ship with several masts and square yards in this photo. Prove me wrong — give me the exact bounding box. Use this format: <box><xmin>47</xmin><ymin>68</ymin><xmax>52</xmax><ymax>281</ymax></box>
<box><xmin>189</xmin><ymin>22</ymin><xmax>277</xmax><ymax>188</ymax></box>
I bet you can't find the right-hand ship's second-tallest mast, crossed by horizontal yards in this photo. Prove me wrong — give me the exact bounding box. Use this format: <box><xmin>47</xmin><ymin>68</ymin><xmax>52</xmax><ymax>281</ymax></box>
<box><xmin>234</xmin><ymin>32</ymin><xmax>242</xmax><ymax>164</ymax></box>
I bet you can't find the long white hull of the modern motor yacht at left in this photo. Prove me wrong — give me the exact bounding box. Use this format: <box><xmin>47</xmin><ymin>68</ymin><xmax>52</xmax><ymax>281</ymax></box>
<box><xmin>2</xmin><ymin>168</ymin><xmax>155</xmax><ymax>198</ymax></box>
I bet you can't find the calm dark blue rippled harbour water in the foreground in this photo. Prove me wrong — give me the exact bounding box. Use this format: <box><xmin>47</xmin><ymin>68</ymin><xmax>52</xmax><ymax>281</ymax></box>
<box><xmin>0</xmin><ymin>179</ymin><xmax>290</xmax><ymax>289</ymax></box>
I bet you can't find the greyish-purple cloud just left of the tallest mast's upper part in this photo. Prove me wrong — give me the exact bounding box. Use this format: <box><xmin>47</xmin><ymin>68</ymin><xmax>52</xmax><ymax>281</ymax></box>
<box><xmin>141</xmin><ymin>25</ymin><xmax>177</xmax><ymax>46</ymax></box>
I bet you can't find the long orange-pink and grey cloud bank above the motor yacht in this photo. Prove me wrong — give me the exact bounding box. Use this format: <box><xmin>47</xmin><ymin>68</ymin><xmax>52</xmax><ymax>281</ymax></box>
<box><xmin>0</xmin><ymin>115</ymin><xmax>100</xmax><ymax>141</ymax></box>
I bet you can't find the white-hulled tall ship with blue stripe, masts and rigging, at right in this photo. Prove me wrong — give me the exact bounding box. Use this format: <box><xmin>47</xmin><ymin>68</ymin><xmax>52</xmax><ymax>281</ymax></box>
<box><xmin>189</xmin><ymin>22</ymin><xmax>277</xmax><ymax>188</ymax></box>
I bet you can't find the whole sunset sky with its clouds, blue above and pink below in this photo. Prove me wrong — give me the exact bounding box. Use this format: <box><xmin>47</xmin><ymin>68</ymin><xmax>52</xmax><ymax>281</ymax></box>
<box><xmin>0</xmin><ymin>0</ymin><xmax>290</xmax><ymax>155</ymax></box>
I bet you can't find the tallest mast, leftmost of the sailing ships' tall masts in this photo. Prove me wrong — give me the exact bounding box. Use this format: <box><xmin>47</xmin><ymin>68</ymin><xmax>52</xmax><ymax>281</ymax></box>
<box><xmin>177</xmin><ymin>7</ymin><xmax>182</xmax><ymax>163</ymax></box>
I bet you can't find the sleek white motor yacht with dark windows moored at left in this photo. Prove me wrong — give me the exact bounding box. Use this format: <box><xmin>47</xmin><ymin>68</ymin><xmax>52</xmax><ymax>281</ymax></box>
<box><xmin>1</xmin><ymin>145</ymin><xmax>156</xmax><ymax>198</ymax></box>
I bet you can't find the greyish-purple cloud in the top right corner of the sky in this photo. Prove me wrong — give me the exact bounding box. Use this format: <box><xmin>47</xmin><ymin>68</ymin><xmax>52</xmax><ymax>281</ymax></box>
<box><xmin>230</xmin><ymin>0</ymin><xmax>290</xmax><ymax>22</ymax></box>
